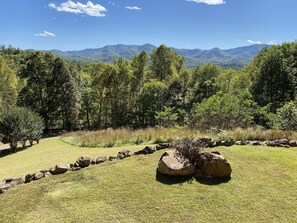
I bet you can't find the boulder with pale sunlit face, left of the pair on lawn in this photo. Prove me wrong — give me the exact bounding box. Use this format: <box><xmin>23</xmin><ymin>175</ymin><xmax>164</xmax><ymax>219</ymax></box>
<box><xmin>158</xmin><ymin>150</ymin><xmax>195</xmax><ymax>176</ymax></box>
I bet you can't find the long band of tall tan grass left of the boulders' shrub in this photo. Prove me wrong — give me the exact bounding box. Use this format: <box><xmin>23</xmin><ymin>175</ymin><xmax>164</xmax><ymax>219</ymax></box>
<box><xmin>61</xmin><ymin>128</ymin><xmax>213</xmax><ymax>147</ymax></box>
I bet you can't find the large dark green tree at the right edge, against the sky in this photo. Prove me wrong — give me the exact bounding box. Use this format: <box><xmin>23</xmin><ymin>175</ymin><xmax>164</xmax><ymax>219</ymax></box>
<box><xmin>248</xmin><ymin>42</ymin><xmax>297</xmax><ymax>113</ymax></box>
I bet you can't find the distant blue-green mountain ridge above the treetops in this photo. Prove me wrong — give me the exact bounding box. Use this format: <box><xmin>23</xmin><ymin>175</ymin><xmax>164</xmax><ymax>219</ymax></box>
<box><xmin>50</xmin><ymin>44</ymin><xmax>271</xmax><ymax>68</ymax></box>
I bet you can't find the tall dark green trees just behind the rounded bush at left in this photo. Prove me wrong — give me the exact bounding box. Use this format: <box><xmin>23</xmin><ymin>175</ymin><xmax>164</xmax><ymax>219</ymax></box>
<box><xmin>18</xmin><ymin>52</ymin><xmax>80</xmax><ymax>130</ymax></box>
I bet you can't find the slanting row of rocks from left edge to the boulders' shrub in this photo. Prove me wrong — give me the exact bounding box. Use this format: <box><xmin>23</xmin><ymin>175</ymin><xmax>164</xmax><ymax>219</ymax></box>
<box><xmin>0</xmin><ymin>143</ymin><xmax>170</xmax><ymax>194</ymax></box>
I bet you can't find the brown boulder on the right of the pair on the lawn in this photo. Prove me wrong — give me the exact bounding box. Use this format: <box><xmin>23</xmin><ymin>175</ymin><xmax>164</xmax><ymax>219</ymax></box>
<box><xmin>196</xmin><ymin>152</ymin><xmax>232</xmax><ymax>178</ymax></box>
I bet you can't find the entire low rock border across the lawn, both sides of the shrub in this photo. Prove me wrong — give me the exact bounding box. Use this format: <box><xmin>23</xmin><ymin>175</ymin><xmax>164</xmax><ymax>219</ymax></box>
<box><xmin>0</xmin><ymin>138</ymin><xmax>297</xmax><ymax>194</ymax></box>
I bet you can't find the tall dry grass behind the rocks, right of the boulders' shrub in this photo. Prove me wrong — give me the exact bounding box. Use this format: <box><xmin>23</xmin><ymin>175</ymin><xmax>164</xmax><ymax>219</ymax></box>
<box><xmin>219</xmin><ymin>126</ymin><xmax>297</xmax><ymax>141</ymax></box>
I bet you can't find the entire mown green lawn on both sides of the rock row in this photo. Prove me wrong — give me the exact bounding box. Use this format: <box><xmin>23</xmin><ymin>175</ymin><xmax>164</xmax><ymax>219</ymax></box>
<box><xmin>0</xmin><ymin>138</ymin><xmax>297</xmax><ymax>223</ymax></box>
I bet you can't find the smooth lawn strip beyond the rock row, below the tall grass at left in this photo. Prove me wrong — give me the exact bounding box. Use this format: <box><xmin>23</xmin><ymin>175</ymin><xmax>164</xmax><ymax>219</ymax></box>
<box><xmin>0</xmin><ymin>137</ymin><xmax>149</xmax><ymax>180</ymax></box>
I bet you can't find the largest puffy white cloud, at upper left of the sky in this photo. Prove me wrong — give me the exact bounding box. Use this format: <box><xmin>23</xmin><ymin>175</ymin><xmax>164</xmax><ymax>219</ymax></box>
<box><xmin>48</xmin><ymin>1</ymin><xmax>107</xmax><ymax>17</ymax></box>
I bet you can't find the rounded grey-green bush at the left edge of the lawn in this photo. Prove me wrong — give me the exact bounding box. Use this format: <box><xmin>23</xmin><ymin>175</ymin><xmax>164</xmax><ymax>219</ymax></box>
<box><xmin>0</xmin><ymin>107</ymin><xmax>43</xmax><ymax>152</ymax></box>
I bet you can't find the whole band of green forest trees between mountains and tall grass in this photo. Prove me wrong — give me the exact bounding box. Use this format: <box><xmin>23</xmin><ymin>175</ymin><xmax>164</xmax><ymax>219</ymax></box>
<box><xmin>0</xmin><ymin>42</ymin><xmax>297</xmax><ymax>131</ymax></box>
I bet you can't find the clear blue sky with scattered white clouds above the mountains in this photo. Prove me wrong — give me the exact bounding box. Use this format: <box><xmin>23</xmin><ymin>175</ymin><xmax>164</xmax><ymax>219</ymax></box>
<box><xmin>0</xmin><ymin>0</ymin><xmax>297</xmax><ymax>50</ymax></box>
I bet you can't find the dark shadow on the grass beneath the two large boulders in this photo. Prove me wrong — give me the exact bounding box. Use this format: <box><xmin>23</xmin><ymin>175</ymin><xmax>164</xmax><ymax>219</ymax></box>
<box><xmin>156</xmin><ymin>169</ymin><xmax>231</xmax><ymax>186</ymax></box>
